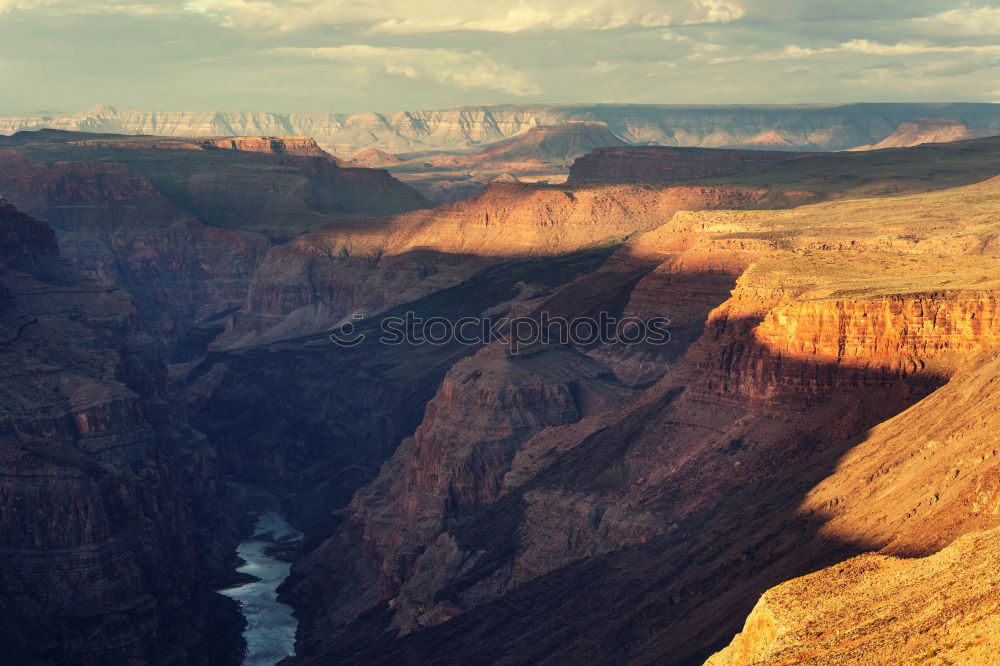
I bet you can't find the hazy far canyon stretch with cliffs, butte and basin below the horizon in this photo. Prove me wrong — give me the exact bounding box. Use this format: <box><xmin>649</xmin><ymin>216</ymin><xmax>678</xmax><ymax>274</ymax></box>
<box><xmin>7</xmin><ymin>103</ymin><xmax>1000</xmax><ymax>204</ymax></box>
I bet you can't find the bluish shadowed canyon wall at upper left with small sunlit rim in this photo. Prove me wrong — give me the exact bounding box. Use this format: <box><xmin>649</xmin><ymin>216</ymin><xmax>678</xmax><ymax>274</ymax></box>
<box><xmin>0</xmin><ymin>132</ymin><xmax>424</xmax><ymax>361</ymax></box>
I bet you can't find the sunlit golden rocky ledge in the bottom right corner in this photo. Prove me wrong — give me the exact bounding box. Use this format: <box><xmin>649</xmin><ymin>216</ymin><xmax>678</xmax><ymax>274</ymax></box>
<box><xmin>705</xmin><ymin>530</ymin><xmax>1000</xmax><ymax>666</ymax></box>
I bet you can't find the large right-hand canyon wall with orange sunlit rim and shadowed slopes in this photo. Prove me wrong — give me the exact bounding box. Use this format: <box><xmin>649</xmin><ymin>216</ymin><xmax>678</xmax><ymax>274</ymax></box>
<box><xmin>289</xmin><ymin>174</ymin><xmax>1000</xmax><ymax>664</ymax></box>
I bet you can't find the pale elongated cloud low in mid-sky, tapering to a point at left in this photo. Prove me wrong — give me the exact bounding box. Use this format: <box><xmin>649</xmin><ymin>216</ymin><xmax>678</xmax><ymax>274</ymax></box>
<box><xmin>270</xmin><ymin>44</ymin><xmax>542</xmax><ymax>95</ymax></box>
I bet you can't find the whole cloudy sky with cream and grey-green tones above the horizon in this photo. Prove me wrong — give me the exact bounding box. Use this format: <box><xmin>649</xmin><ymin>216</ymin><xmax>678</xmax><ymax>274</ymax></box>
<box><xmin>0</xmin><ymin>0</ymin><xmax>1000</xmax><ymax>113</ymax></box>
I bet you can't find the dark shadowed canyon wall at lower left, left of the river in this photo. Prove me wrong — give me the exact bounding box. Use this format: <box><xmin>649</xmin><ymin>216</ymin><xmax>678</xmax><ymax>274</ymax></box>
<box><xmin>0</xmin><ymin>200</ymin><xmax>232</xmax><ymax>666</ymax></box>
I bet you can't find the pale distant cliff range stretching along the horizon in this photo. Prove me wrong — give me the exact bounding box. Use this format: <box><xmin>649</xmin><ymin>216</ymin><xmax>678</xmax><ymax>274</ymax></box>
<box><xmin>0</xmin><ymin>103</ymin><xmax>1000</xmax><ymax>157</ymax></box>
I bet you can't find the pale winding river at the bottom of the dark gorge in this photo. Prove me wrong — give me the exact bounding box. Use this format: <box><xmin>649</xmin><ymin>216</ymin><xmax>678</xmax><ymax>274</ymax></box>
<box><xmin>219</xmin><ymin>511</ymin><xmax>302</xmax><ymax>666</ymax></box>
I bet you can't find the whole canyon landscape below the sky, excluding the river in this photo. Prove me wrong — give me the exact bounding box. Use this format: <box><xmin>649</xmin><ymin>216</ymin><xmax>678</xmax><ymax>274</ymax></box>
<box><xmin>0</xmin><ymin>126</ymin><xmax>1000</xmax><ymax>665</ymax></box>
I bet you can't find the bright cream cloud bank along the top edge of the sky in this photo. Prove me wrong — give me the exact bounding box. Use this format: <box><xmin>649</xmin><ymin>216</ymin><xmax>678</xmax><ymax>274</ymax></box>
<box><xmin>186</xmin><ymin>0</ymin><xmax>744</xmax><ymax>35</ymax></box>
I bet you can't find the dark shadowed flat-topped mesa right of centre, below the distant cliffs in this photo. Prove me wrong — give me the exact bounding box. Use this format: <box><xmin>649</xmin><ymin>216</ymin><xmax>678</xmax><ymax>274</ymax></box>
<box><xmin>568</xmin><ymin>146</ymin><xmax>809</xmax><ymax>183</ymax></box>
